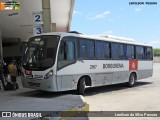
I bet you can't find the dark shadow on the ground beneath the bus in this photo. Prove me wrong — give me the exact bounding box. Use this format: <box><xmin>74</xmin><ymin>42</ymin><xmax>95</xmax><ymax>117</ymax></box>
<box><xmin>14</xmin><ymin>82</ymin><xmax>152</xmax><ymax>98</ymax></box>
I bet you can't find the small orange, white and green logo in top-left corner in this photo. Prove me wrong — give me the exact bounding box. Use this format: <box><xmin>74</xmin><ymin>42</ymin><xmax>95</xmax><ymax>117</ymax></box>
<box><xmin>0</xmin><ymin>1</ymin><xmax>20</xmax><ymax>10</ymax></box>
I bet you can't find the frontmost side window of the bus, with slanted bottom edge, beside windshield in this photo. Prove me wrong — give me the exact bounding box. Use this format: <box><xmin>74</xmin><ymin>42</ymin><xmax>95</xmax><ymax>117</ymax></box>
<box><xmin>58</xmin><ymin>41</ymin><xmax>75</xmax><ymax>68</ymax></box>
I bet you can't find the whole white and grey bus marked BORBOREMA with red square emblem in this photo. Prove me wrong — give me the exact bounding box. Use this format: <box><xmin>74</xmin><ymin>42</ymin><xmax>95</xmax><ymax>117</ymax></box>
<box><xmin>22</xmin><ymin>32</ymin><xmax>153</xmax><ymax>94</ymax></box>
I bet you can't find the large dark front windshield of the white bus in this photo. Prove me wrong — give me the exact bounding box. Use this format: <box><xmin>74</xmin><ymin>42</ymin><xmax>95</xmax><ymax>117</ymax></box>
<box><xmin>23</xmin><ymin>35</ymin><xmax>60</xmax><ymax>71</ymax></box>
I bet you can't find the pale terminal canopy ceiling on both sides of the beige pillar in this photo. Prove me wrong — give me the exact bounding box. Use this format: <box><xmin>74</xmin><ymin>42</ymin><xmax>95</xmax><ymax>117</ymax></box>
<box><xmin>0</xmin><ymin>0</ymin><xmax>74</xmax><ymax>41</ymax></box>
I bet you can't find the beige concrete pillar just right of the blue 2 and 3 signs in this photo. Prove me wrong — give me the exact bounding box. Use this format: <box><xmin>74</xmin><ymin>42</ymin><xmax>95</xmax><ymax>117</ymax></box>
<box><xmin>42</xmin><ymin>0</ymin><xmax>51</xmax><ymax>33</ymax></box>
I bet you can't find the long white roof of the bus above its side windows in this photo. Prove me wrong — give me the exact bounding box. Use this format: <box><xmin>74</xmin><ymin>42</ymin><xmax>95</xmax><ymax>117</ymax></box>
<box><xmin>39</xmin><ymin>32</ymin><xmax>152</xmax><ymax>47</ymax></box>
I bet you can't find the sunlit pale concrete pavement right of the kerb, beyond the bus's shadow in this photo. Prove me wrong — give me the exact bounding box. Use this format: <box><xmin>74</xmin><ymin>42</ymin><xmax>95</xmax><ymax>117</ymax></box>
<box><xmin>84</xmin><ymin>63</ymin><xmax>160</xmax><ymax>120</ymax></box>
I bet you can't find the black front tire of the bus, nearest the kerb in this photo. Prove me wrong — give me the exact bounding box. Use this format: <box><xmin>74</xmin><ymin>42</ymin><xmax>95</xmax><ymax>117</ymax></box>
<box><xmin>77</xmin><ymin>77</ymin><xmax>85</xmax><ymax>95</ymax></box>
